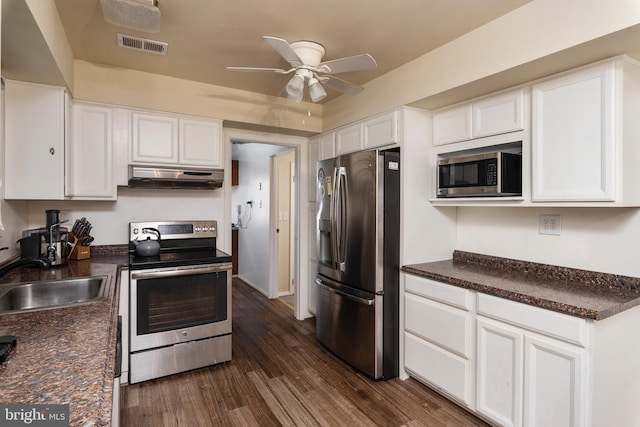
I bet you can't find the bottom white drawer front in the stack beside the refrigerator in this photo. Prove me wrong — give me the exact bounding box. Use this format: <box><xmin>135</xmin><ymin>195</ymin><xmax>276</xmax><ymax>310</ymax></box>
<box><xmin>404</xmin><ymin>332</ymin><xmax>473</xmax><ymax>406</ymax></box>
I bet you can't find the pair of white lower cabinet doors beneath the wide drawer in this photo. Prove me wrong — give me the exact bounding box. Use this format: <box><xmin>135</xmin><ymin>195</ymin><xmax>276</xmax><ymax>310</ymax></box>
<box><xmin>476</xmin><ymin>316</ymin><xmax>586</xmax><ymax>427</ymax></box>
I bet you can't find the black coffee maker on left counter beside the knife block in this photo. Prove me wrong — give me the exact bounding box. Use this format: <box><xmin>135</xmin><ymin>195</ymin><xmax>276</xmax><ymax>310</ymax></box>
<box><xmin>19</xmin><ymin>209</ymin><xmax>69</xmax><ymax>266</ymax></box>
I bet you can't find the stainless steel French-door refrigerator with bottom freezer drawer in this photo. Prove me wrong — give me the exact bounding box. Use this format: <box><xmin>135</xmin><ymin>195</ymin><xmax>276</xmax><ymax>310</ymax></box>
<box><xmin>316</xmin><ymin>149</ymin><xmax>400</xmax><ymax>379</ymax></box>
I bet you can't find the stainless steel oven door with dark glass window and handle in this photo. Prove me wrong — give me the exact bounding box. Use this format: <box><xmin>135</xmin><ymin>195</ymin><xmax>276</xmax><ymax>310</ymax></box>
<box><xmin>130</xmin><ymin>263</ymin><xmax>231</xmax><ymax>352</ymax></box>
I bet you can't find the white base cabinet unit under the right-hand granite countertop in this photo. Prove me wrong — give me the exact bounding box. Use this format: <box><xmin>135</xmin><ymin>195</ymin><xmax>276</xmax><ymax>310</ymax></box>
<box><xmin>403</xmin><ymin>274</ymin><xmax>628</xmax><ymax>427</ymax></box>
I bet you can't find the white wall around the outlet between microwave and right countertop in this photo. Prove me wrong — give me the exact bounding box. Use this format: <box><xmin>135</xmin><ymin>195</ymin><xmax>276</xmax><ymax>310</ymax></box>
<box><xmin>456</xmin><ymin>207</ymin><xmax>640</xmax><ymax>277</ymax></box>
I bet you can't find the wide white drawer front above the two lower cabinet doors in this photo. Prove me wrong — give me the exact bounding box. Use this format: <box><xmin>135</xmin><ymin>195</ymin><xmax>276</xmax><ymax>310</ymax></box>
<box><xmin>478</xmin><ymin>294</ymin><xmax>587</xmax><ymax>347</ymax></box>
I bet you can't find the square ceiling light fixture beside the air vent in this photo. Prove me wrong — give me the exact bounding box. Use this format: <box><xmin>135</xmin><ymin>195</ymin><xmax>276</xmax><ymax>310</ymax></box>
<box><xmin>100</xmin><ymin>0</ymin><xmax>160</xmax><ymax>33</ymax></box>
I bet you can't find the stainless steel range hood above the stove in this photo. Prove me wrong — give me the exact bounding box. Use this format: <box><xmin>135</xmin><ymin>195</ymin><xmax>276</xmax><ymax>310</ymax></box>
<box><xmin>129</xmin><ymin>166</ymin><xmax>224</xmax><ymax>190</ymax></box>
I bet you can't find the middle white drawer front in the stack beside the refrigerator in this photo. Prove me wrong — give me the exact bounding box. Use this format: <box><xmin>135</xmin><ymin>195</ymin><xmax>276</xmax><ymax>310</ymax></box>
<box><xmin>405</xmin><ymin>294</ymin><xmax>472</xmax><ymax>359</ymax></box>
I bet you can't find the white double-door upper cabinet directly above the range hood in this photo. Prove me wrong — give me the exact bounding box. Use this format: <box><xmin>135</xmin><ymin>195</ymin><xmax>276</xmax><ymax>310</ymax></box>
<box><xmin>131</xmin><ymin>111</ymin><xmax>222</xmax><ymax>167</ymax></box>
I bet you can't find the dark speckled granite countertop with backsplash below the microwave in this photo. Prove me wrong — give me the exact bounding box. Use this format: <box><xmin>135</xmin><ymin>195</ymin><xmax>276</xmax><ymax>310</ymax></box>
<box><xmin>402</xmin><ymin>251</ymin><xmax>640</xmax><ymax>320</ymax></box>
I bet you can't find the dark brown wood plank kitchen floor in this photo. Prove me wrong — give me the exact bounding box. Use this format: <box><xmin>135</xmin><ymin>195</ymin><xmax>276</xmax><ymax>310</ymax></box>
<box><xmin>122</xmin><ymin>278</ymin><xmax>486</xmax><ymax>427</ymax></box>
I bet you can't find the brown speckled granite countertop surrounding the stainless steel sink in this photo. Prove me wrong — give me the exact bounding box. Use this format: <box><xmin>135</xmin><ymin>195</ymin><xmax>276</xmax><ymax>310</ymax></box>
<box><xmin>0</xmin><ymin>254</ymin><xmax>128</xmax><ymax>426</ymax></box>
